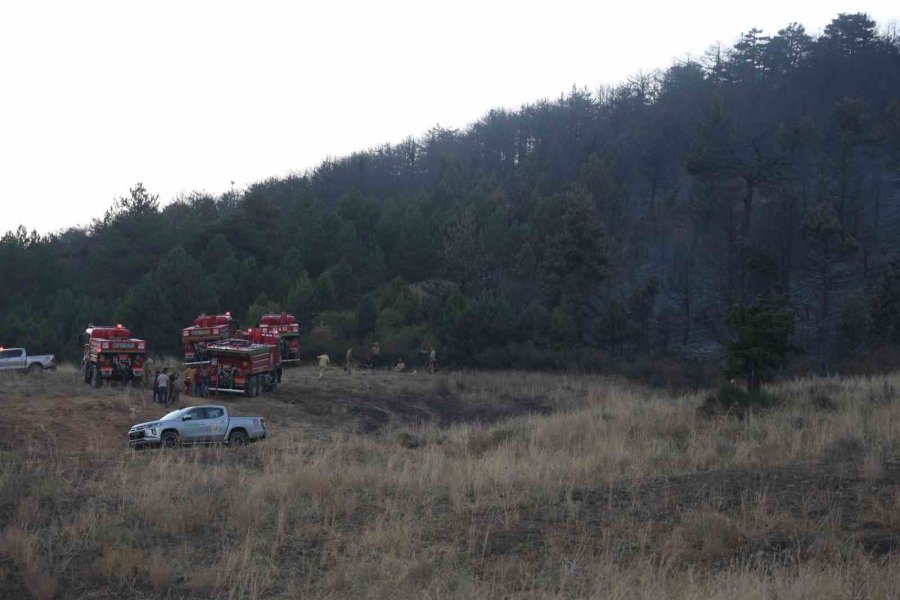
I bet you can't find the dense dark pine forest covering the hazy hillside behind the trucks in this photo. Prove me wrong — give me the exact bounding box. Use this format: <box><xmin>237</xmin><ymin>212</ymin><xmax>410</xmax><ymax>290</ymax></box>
<box><xmin>0</xmin><ymin>14</ymin><xmax>900</xmax><ymax>380</ymax></box>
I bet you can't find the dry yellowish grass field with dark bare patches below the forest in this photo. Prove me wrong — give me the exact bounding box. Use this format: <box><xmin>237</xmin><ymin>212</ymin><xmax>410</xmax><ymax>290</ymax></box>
<box><xmin>0</xmin><ymin>368</ymin><xmax>900</xmax><ymax>599</ymax></box>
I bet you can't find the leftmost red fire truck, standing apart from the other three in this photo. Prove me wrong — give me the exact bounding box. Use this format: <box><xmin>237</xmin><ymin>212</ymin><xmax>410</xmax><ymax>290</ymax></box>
<box><xmin>80</xmin><ymin>324</ymin><xmax>147</xmax><ymax>387</ymax></box>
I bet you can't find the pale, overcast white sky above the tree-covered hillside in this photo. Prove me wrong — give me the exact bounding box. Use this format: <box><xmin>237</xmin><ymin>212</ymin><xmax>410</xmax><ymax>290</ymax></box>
<box><xmin>0</xmin><ymin>0</ymin><xmax>900</xmax><ymax>233</ymax></box>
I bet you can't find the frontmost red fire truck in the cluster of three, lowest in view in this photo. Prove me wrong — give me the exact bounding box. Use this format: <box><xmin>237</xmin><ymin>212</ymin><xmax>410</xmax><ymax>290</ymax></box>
<box><xmin>206</xmin><ymin>329</ymin><xmax>281</xmax><ymax>398</ymax></box>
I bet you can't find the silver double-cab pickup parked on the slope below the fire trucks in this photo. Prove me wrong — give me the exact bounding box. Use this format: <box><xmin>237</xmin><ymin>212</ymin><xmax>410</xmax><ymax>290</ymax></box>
<box><xmin>128</xmin><ymin>405</ymin><xmax>266</xmax><ymax>448</ymax></box>
